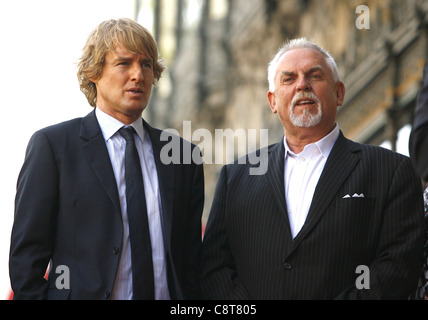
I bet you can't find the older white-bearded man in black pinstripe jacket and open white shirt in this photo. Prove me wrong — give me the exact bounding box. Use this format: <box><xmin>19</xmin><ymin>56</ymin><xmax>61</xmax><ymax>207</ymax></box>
<box><xmin>201</xmin><ymin>39</ymin><xmax>424</xmax><ymax>299</ymax></box>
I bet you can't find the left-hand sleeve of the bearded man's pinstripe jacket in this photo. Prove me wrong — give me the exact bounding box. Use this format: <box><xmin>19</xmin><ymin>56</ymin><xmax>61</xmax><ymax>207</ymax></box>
<box><xmin>201</xmin><ymin>166</ymin><xmax>251</xmax><ymax>300</ymax></box>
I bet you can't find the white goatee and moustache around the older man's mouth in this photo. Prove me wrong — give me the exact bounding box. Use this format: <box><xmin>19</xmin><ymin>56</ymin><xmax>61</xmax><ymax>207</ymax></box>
<box><xmin>290</xmin><ymin>92</ymin><xmax>322</xmax><ymax>128</ymax></box>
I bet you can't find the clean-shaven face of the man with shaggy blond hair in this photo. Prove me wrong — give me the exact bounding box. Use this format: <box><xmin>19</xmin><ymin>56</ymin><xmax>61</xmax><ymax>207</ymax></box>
<box><xmin>92</xmin><ymin>46</ymin><xmax>154</xmax><ymax>124</ymax></box>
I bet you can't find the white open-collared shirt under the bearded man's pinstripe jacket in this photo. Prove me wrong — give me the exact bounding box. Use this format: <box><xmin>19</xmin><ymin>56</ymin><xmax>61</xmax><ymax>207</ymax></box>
<box><xmin>284</xmin><ymin>124</ymin><xmax>339</xmax><ymax>239</ymax></box>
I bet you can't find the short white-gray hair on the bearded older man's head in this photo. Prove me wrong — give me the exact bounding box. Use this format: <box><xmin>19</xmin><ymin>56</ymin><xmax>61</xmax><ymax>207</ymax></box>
<box><xmin>268</xmin><ymin>38</ymin><xmax>341</xmax><ymax>92</ymax></box>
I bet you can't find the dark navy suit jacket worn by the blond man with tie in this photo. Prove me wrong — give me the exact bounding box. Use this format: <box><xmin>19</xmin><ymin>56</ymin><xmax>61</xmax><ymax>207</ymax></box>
<box><xmin>10</xmin><ymin>112</ymin><xmax>204</xmax><ymax>299</ymax></box>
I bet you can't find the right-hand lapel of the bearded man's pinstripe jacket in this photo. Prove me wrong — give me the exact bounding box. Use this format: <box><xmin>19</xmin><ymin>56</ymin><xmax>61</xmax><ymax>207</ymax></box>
<box><xmin>293</xmin><ymin>132</ymin><xmax>361</xmax><ymax>249</ymax></box>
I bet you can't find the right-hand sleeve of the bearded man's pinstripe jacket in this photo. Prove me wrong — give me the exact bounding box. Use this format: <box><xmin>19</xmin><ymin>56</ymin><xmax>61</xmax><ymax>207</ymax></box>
<box><xmin>338</xmin><ymin>158</ymin><xmax>424</xmax><ymax>299</ymax></box>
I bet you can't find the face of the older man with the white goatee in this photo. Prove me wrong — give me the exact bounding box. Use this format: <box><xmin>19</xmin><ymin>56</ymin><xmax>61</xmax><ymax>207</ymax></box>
<box><xmin>268</xmin><ymin>49</ymin><xmax>345</xmax><ymax>133</ymax></box>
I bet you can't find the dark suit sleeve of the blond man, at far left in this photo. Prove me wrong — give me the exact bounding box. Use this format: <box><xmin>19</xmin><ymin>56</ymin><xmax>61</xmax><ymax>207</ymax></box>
<box><xmin>9</xmin><ymin>132</ymin><xmax>58</xmax><ymax>299</ymax></box>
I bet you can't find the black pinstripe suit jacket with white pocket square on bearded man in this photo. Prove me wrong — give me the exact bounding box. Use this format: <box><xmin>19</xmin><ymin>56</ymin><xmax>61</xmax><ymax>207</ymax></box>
<box><xmin>201</xmin><ymin>133</ymin><xmax>423</xmax><ymax>299</ymax></box>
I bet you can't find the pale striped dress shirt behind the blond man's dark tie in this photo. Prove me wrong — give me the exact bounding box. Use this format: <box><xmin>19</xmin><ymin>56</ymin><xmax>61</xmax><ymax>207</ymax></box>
<box><xmin>95</xmin><ymin>108</ymin><xmax>170</xmax><ymax>300</ymax></box>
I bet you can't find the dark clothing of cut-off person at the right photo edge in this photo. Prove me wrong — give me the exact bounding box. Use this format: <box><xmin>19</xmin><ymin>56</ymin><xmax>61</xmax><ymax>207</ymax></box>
<box><xmin>409</xmin><ymin>63</ymin><xmax>428</xmax><ymax>182</ymax></box>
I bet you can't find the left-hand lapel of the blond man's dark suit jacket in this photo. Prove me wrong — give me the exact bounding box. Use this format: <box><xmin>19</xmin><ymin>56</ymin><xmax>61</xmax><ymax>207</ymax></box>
<box><xmin>80</xmin><ymin>110</ymin><xmax>120</xmax><ymax>212</ymax></box>
